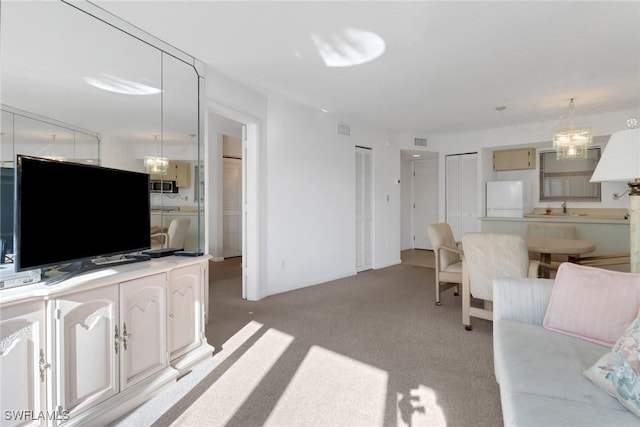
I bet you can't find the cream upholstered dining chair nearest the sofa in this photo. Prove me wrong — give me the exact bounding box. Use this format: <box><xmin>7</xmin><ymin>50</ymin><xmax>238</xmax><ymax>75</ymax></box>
<box><xmin>462</xmin><ymin>232</ymin><xmax>540</xmax><ymax>331</ymax></box>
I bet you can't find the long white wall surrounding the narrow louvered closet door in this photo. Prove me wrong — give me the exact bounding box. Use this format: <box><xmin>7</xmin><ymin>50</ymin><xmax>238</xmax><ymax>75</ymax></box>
<box><xmin>266</xmin><ymin>99</ymin><xmax>400</xmax><ymax>293</ymax></box>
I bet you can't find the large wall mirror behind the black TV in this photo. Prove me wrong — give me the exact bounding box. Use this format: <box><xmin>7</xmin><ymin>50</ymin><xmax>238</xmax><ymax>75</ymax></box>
<box><xmin>0</xmin><ymin>1</ymin><xmax>204</xmax><ymax>276</ymax></box>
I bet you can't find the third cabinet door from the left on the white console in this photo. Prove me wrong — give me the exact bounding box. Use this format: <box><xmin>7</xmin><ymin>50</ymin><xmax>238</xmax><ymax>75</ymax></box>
<box><xmin>120</xmin><ymin>273</ymin><xmax>168</xmax><ymax>390</ymax></box>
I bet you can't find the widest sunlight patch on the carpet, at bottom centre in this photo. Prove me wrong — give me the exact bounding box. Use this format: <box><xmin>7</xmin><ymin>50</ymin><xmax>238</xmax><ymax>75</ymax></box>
<box><xmin>265</xmin><ymin>346</ymin><xmax>388</xmax><ymax>427</ymax></box>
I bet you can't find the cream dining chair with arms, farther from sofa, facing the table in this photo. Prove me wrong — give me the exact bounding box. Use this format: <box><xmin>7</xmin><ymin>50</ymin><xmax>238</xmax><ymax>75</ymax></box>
<box><xmin>427</xmin><ymin>222</ymin><xmax>463</xmax><ymax>305</ymax></box>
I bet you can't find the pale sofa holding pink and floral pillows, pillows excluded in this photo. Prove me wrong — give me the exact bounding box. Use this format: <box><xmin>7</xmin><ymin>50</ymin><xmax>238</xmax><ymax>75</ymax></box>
<box><xmin>493</xmin><ymin>278</ymin><xmax>640</xmax><ymax>427</ymax></box>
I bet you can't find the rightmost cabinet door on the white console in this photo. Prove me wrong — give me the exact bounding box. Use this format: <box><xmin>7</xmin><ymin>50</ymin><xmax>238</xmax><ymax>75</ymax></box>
<box><xmin>169</xmin><ymin>264</ymin><xmax>204</xmax><ymax>360</ymax></box>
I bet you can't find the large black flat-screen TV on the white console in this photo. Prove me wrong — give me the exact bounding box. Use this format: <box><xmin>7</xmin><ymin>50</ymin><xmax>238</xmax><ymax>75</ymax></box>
<box><xmin>14</xmin><ymin>155</ymin><xmax>151</xmax><ymax>271</ymax></box>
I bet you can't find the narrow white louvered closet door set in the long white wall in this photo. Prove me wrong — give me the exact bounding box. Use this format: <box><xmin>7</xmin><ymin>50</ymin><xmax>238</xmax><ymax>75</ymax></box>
<box><xmin>356</xmin><ymin>147</ymin><xmax>373</xmax><ymax>271</ymax></box>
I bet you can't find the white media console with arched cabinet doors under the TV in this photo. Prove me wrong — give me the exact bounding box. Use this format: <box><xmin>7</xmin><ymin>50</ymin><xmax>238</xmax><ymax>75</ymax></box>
<box><xmin>0</xmin><ymin>256</ymin><xmax>214</xmax><ymax>426</ymax></box>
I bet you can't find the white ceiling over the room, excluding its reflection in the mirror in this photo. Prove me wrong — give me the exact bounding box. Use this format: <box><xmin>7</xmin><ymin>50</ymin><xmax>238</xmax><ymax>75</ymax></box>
<box><xmin>55</xmin><ymin>0</ymin><xmax>640</xmax><ymax>136</ymax></box>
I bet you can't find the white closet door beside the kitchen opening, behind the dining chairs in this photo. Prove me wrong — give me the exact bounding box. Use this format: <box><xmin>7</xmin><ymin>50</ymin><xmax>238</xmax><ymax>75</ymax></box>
<box><xmin>445</xmin><ymin>153</ymin><xmax>479</xmax><ymax>240</ymax></box>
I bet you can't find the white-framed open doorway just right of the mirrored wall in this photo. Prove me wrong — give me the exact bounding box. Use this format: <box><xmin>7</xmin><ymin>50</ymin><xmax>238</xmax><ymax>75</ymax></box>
<box><xmin>205</xmin><ymin>102</ymin><xmax>264</xmax><ymax>301</ymax></box>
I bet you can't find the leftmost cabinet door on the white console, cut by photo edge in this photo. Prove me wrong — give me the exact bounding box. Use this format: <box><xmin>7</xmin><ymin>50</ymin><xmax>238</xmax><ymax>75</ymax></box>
<box><xmin>0</xmin><ymin>301</ymin><xmax>48</xmax><ymax>426</ymax></box>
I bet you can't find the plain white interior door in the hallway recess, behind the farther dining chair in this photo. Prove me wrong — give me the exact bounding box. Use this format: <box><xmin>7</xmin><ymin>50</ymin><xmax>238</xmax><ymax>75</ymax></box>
<box><xmin>412</xmin><ymin>158</ymin><xmax>438</xmax><ymax>249</ymax></box>
